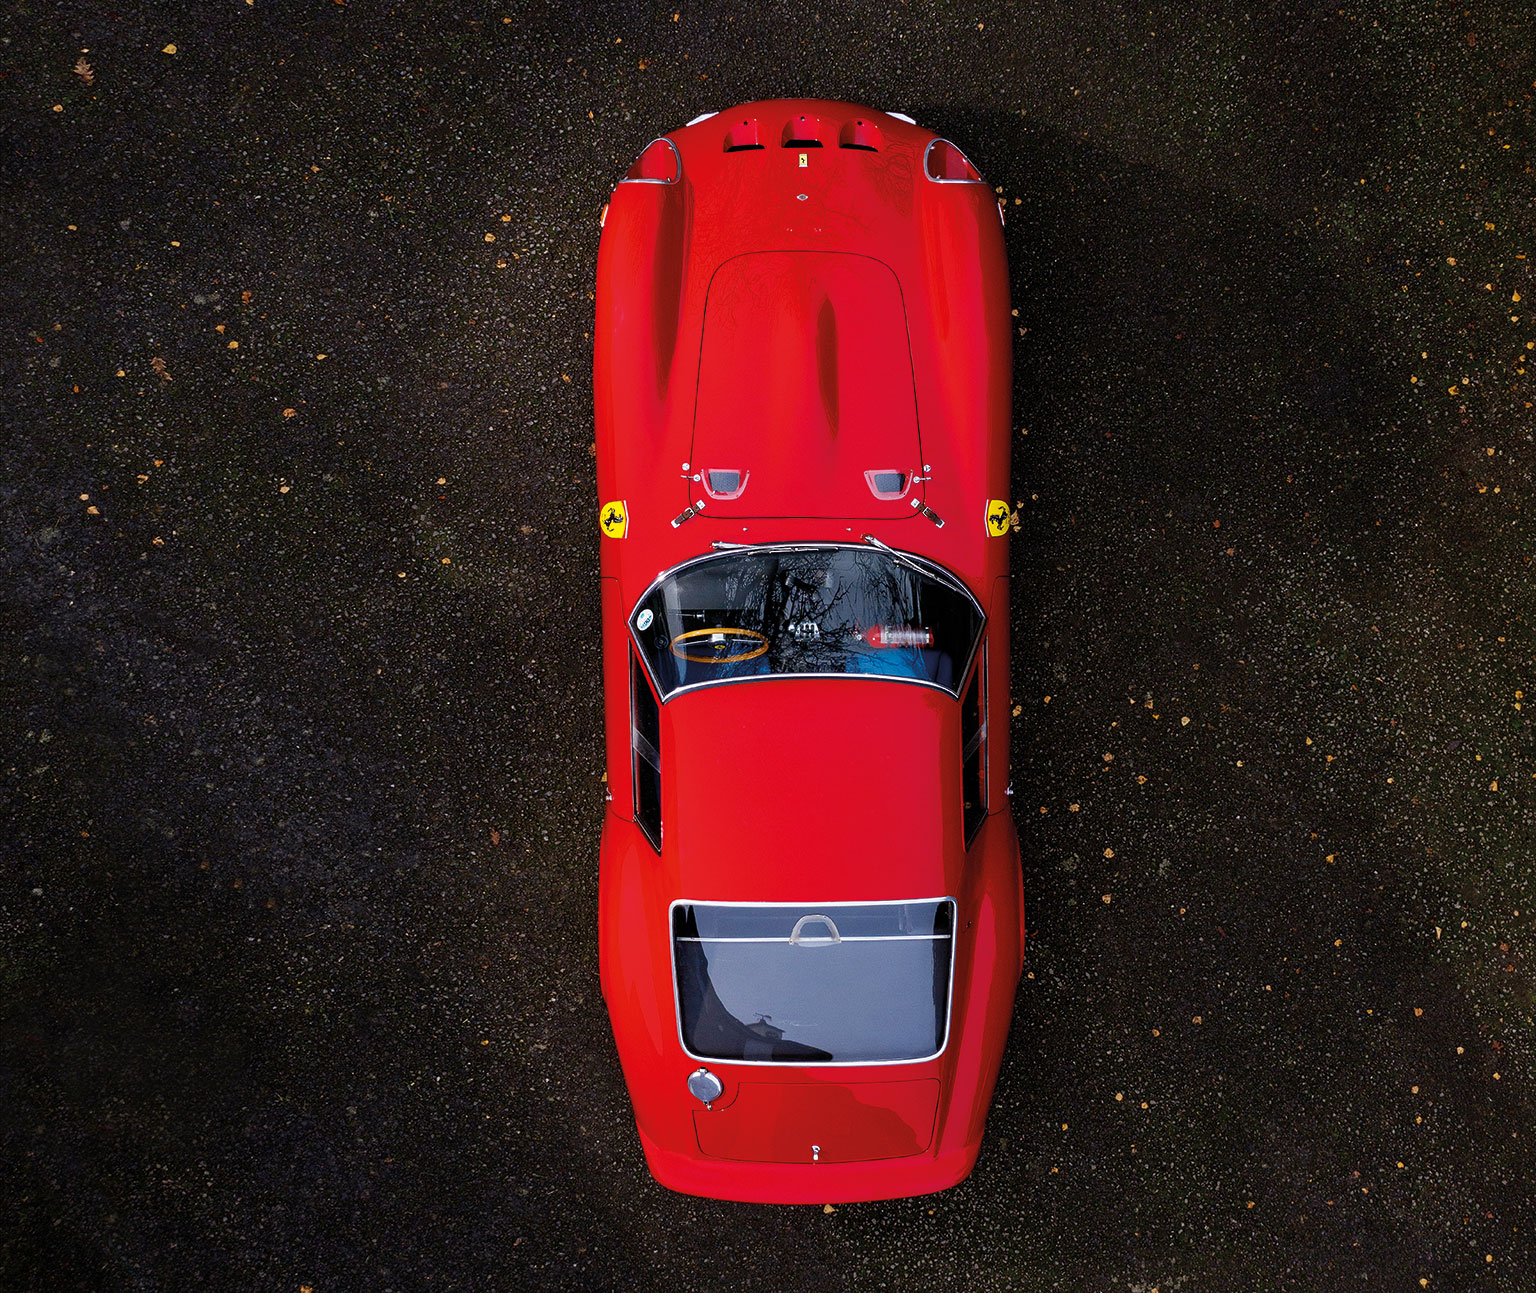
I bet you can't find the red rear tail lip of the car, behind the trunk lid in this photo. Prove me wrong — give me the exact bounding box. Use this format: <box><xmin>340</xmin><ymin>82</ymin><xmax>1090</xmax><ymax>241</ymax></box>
<box><xmin>641</xmin><ymin>1130</ymin><xmax>980</xmax><ymax>1204</ymax></box>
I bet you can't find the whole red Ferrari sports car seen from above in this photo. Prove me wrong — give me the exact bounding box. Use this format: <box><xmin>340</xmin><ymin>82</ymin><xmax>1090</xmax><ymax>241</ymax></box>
<box><xmin>593</xmin><ymin>100</ymin><xmax>1025</xmax><ymax>1202</ymax></box>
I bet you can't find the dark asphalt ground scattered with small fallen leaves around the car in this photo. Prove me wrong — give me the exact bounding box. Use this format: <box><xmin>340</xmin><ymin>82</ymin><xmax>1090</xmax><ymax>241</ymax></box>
<box><xmin>0</xmin><ymin>0</ymin><xmax>1536</xmax><ymax>1293</ymax></box>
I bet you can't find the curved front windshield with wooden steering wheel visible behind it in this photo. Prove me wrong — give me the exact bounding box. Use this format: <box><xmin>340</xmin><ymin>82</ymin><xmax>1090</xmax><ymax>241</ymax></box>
<box><xmin>631</xmin><ymin>545</ymin><xmax>982</xmax><ymax>700</ymax></box>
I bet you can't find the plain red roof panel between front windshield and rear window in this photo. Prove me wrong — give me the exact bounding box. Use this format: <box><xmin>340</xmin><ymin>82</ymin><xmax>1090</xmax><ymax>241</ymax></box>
<box><xmin>662</xmin><ymin>677</ymin><xmax>963</xmax><ymax>901</ymax></box>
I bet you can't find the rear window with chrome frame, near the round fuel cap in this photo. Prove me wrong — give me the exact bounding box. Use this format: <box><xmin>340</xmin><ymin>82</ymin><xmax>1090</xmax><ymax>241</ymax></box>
<box><xmin>673</xmin><ymin>898</ymin><xmax>954</xmax><ymax>1064</ymax></box>
